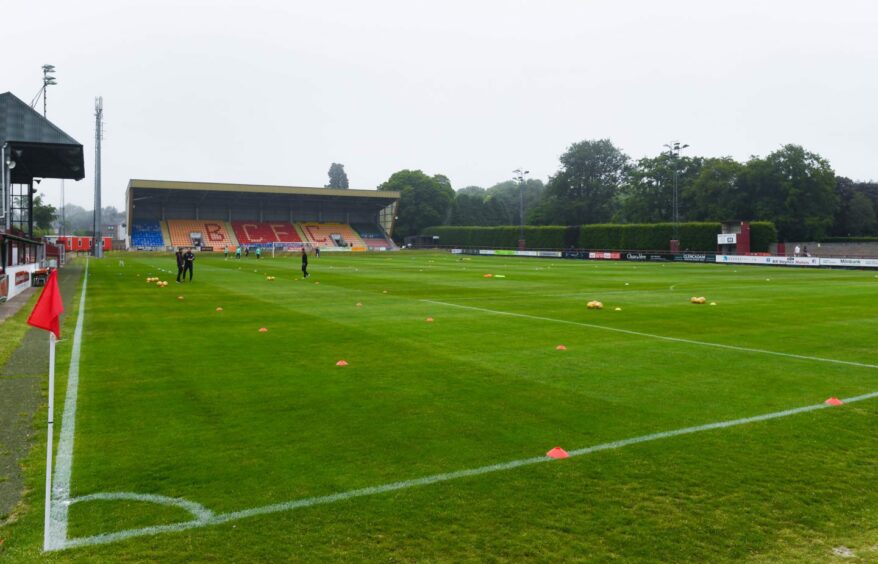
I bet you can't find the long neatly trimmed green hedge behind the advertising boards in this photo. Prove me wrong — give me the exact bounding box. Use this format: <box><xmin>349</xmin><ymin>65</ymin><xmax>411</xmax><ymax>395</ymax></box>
<box><xmin>422</xmin><ymin>221</ymin><xmax>777</xmax><ymax>252</ymax></box>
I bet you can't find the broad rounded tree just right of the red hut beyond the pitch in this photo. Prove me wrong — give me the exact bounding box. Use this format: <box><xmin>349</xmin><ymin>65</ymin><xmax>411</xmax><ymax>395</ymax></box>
<box><xmin>741</xmin><ymin>145</ymin><xmax>838</xmax><ymax>241</ymax></box>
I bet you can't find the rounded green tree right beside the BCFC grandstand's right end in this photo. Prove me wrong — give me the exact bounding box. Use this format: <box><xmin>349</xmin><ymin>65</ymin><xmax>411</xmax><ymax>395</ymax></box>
<box><xmin>378</xmin><ymin>170</ymin><xmax>454</xmax><ymax>242</ymax></box>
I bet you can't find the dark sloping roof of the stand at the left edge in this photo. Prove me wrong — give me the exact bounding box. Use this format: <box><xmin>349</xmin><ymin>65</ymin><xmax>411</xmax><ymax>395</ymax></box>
<box><xmin>0</xmin><ymin>92</ymin><xmax>85</xmax><ymax>183</ymax></box>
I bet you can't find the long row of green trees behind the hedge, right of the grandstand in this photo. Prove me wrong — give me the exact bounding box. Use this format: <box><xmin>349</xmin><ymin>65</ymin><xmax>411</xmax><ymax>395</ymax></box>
<box><xmin>378</xmin><ymin>139</ymin><xmax>878</xmax><ymax>241</ymax></box>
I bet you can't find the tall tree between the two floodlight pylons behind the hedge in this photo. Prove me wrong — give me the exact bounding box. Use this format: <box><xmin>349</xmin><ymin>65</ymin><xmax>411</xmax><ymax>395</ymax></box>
<box><xmin>531</xmin><ymin>139</ymin><xmax>629</xmax><ymax>225</ymax></box>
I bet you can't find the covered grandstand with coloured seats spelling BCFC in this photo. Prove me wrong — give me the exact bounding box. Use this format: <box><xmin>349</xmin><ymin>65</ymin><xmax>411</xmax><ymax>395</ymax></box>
<box><xmin>126</xmin><ymin>180</ymin><xmax>399</xmax><ymax>251</ymax></box>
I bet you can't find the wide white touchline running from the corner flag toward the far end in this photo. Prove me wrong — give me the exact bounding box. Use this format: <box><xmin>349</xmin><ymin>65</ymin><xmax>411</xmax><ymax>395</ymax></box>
<box><xmin>46</xmin><ymin>257</ymin><xmax>88</xmax><ymax>550</ymax></box>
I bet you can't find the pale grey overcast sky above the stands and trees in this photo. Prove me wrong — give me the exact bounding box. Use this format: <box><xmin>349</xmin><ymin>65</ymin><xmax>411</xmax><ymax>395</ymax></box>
<box><xmin>6</xmin><ymin>0</ymin><xmax>878</xmax><ymax>208</ymax></box>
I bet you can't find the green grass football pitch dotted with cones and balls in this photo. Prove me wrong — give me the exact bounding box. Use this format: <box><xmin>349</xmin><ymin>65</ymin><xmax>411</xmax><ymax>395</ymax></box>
<box><xmin>6</xmin><ymin>251</ymin><xmax>878</xmax><ymax>562</ymax></box>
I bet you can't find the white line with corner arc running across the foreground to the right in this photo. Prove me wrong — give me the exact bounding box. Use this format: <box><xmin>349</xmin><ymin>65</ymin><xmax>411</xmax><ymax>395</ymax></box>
<box><xmin>59</xmin><ymin>392</ymin><xmax>878</xmax><ymax>548</ymax></box>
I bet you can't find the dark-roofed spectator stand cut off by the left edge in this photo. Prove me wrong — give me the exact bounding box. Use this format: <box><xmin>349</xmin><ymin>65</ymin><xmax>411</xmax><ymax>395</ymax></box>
<box><xmin>0</xmin><ymin>92</ymin><xmax>85</xmax><ymax>301</ymax></box>
